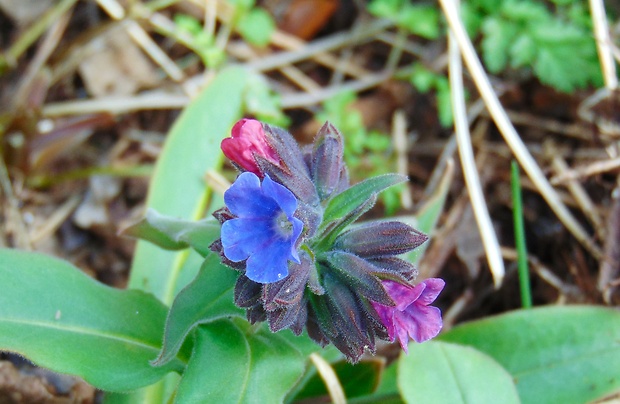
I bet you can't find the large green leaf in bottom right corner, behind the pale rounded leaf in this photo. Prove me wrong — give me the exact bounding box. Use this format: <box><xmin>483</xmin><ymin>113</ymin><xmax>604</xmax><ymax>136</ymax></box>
<box><xmin>439</xmin><ymin>306</ymin><xmax>620</xmax><ymax>404</ymax></box>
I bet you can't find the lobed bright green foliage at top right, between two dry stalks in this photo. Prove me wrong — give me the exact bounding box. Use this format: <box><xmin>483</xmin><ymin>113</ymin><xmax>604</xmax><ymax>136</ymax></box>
<box><xmin>463</xmin><ymin>0</ymin><xmax>602</xmax><ymax>92</ymax></box>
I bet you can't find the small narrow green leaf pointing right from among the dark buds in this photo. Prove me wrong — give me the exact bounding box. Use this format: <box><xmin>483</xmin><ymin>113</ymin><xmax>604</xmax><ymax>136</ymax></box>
<box><xmin>323</xmin><ymin>174</ymin><xmax>407</xmax><ymax>223</ymax></box>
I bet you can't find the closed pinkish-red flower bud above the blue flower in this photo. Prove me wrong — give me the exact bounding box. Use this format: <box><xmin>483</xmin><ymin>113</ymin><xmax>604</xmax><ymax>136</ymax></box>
<box><xmin>221</xmin><ymin>119</ymin><xmax>280</xmax><ymax>177</ymax></box>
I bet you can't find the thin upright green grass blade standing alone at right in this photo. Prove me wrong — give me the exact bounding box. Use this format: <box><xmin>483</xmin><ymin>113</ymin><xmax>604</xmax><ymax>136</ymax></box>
<box><xmin>510</xmin><ymin>160</ymin><xmax>532</xmax><ymax>309</ymax></box>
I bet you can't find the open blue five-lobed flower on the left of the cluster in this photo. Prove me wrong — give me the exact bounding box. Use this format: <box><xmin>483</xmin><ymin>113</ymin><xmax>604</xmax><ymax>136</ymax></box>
<box><xmin>221</xmin><ymin>172</ymin><xmax>303</xmax><ymax>283</ymax></box>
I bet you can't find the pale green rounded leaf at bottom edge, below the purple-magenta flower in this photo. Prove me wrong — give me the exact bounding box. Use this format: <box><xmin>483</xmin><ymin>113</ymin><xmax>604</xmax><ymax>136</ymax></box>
<box><xmin>398</xmin><ymin>341</ymin><xmax>520</xmax><ymax>404</ymax></box>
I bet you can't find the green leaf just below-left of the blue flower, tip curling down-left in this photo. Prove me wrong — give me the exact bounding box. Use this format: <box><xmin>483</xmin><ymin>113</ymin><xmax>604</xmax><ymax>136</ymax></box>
<box><xmin>153</xmin><ymin>252</ymin><xmax>244</xmax><ymax>366</ymax></box>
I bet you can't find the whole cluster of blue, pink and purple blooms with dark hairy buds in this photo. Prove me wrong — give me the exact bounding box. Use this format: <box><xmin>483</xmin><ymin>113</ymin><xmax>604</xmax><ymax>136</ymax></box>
<box><xmin>212</xmin><ymin>119</ymin><xmax>444</xmax><ymax>362</ymax></box>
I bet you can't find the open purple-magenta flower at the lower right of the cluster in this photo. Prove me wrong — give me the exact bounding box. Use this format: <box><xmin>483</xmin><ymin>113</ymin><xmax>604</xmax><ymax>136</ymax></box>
<box><xmin>372</xmin><ymin>278</ymin><xmax>445</xmax><ymax>352</ymax></box>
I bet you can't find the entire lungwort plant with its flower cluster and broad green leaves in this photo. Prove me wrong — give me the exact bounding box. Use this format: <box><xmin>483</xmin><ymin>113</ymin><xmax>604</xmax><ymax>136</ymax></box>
<box><xmin>0</xmin><ymin>68</ymin><xmax>620</xmax><ymax>403</ymax></box>
